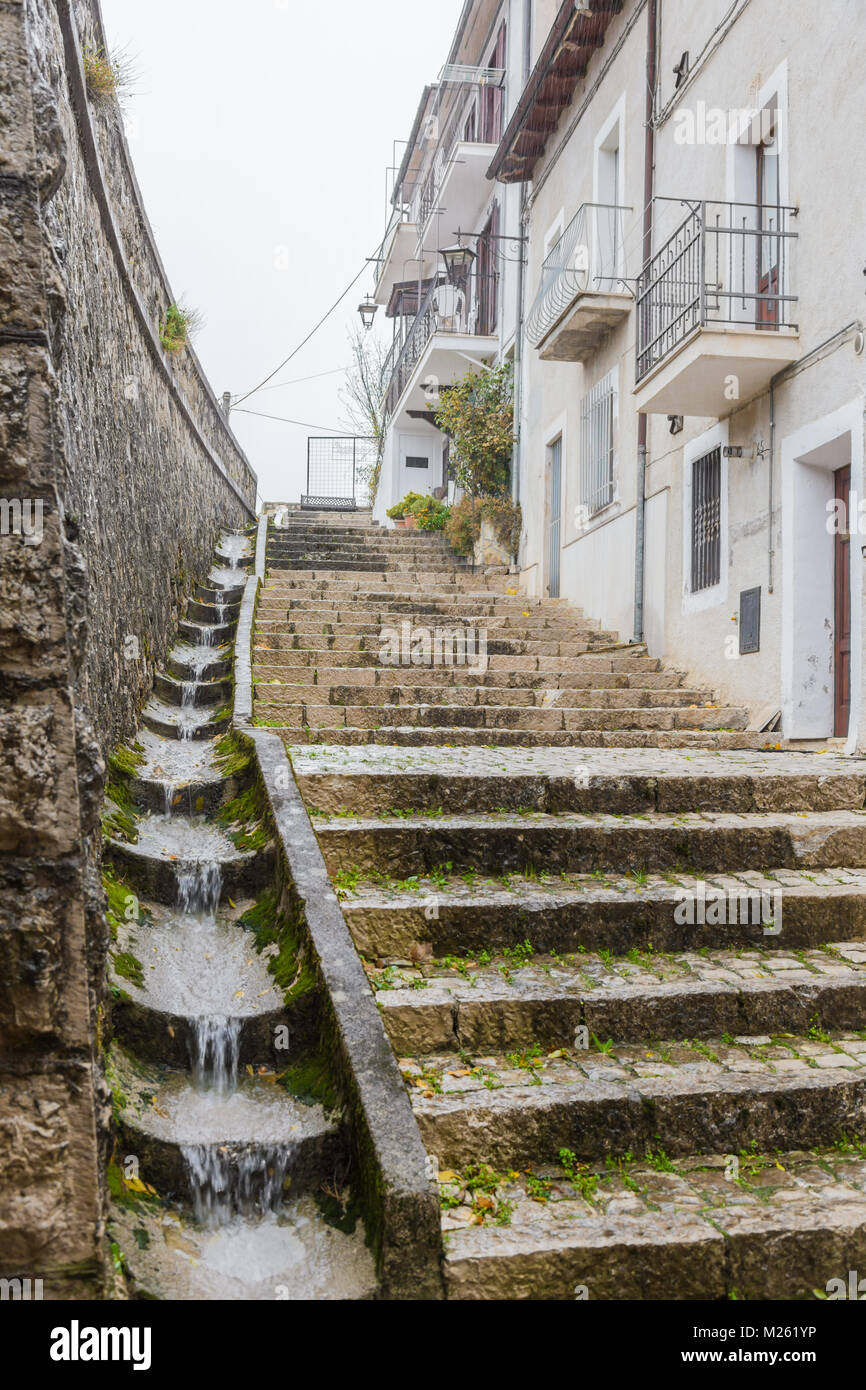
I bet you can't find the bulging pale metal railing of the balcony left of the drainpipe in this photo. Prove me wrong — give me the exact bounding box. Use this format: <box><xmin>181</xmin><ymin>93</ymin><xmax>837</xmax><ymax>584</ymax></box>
<box><xmin>527</xmin><ymin>203</ymin><xmax>631</xmax><ymax>348</ymax></box>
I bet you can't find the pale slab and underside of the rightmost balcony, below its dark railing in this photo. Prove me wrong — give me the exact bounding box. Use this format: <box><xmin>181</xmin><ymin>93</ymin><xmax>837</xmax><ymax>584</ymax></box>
<box><xmin>634</xmin><ymin>324</ymin><xmax>799</xmax><ymax>420</ymax></box>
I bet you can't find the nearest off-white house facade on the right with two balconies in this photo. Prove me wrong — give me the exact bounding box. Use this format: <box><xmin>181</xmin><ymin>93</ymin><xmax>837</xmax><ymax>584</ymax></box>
<box><xmin>497</xmin><ymin>0</ymin><xmax>866</xmax><ymax>751</ymax></box>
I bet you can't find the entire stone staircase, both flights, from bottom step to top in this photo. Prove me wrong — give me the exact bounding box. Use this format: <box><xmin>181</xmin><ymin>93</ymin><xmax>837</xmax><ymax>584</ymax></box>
<box><xmin>253</xmin><ymin>520</ymin><xmax>866</xmax><ymax>1300</ymax></box>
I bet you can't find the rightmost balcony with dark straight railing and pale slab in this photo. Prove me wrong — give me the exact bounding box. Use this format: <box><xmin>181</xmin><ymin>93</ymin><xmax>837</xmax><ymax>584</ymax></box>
<box><xmin>634</xmin><ymin>199</ymin><xmax>799</xmax><ymax>420</ymax></box>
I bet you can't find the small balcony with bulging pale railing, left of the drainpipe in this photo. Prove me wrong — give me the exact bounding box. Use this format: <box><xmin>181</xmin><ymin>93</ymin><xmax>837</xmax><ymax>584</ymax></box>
<box><xmin>527</xmin><ymin>203</ymin><xmax>634</xmax><ymax>361</ymax></box>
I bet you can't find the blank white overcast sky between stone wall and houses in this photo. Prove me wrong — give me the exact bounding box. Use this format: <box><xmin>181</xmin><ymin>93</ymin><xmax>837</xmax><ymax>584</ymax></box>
<box><xmin>103</xmin><ymin>0</ymin><xmax>461</xmax><ymax>502</ymax></box>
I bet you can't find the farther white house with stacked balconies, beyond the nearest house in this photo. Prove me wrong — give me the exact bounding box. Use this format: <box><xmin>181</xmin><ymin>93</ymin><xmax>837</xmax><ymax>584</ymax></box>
<box><xmin>374</xmin><ymin>0</ymin><xmax>531</xmax><ymax>521</ymax></box>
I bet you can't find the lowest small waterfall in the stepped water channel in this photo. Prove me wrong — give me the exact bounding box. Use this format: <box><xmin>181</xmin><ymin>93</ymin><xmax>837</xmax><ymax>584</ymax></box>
<box><xmin>181</xmin><ymin>1144</ymin><xmax>293</xmax><ymax>1229</ymax></box>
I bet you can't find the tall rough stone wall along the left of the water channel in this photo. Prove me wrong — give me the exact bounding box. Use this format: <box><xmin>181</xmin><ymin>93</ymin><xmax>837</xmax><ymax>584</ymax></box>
<box><xmin>0</xmin><ymin>0</ymin><xmax>256</xmax><ymax>1297</ymax></box>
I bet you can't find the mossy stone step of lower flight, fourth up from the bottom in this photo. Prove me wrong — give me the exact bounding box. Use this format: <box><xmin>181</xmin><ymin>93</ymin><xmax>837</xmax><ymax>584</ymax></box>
<box><xmin>340</xmin><ymin>861</ymin><xmax>866</xmax><ymax>965</ymax></box>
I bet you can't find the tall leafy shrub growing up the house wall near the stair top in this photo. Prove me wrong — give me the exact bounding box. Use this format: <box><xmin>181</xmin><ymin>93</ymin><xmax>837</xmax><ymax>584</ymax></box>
<box><xmin>436</xmin><ymin>361</ymin><xmax>514</xmax><ymax>498</ymax></box>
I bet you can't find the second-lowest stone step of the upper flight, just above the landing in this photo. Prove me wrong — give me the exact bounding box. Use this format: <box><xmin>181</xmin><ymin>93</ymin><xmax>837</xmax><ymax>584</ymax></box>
<box><xmin>254</xmin><ymin>700</ymin><xmax>748</xmax><ymax>734</ymax></box>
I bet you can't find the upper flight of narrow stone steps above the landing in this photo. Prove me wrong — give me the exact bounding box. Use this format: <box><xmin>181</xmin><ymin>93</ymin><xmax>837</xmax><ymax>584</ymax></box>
<box><xmin>253</xmin><ymin>513</ymin><xmax>767</xmax><ymax>748</ymax></box>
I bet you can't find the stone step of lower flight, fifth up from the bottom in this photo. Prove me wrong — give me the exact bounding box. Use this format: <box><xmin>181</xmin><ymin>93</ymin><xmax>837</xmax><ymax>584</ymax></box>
<box><xmin>316</xmin><ymin>810</ymin><xmax>866</xmax><ymax>878</ymax></box>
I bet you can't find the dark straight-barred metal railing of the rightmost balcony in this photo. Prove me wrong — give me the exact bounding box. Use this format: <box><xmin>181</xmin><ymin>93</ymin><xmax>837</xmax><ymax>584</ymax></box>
<box><xmin>635</xmin><ymin>199</ymin><xmax>796</xmax><ymax>382</ymax></box>
